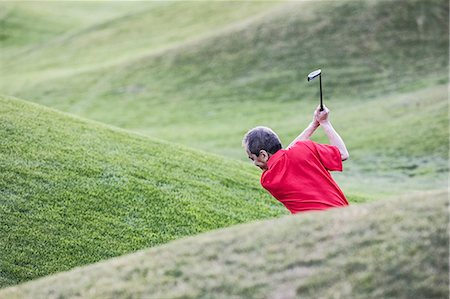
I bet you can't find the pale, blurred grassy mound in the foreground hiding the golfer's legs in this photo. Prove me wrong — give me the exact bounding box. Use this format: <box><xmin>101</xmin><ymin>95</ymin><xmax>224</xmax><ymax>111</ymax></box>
<box><xmin>0</xmin><ymin>191</ymin><xmax>449</xmax><ymax>299</ymax></box>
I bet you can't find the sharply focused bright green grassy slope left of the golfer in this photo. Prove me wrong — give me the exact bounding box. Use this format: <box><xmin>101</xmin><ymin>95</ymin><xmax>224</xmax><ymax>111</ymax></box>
<box><xmin>0</xmin><ymin>97</ymin><xmax>287</xmax><ymax>286</ymax></box>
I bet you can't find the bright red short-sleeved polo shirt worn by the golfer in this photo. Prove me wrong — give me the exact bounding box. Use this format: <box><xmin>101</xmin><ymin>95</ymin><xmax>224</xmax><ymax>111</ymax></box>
<box><xmin>261</xmin><ymin>140</ymin><xmax>348</xmax><ymax>214</ymax></box>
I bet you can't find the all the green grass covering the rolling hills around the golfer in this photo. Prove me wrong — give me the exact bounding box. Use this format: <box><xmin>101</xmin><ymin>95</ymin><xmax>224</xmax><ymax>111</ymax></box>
<box><xmin>0</xmin><ymin>0</ymin><xmax>449</xmax><ymax>298</ymax></box>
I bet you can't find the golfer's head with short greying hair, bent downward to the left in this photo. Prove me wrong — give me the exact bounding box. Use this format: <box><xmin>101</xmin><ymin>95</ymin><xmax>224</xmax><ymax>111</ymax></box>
<box><xmin>242</xmin><ymin>127</ymin><xmax>281</xmax><ymax>170</ymax></box>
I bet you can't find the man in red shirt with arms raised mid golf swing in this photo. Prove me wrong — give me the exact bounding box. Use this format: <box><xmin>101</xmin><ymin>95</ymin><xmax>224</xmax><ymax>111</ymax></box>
<box><xmin>242</xmin><ymin>107</ymin><xmax>349</xmax><ymax>214</ymax></box>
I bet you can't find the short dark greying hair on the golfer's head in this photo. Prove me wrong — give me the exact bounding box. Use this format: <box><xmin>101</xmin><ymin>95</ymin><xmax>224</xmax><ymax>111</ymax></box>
<box><xmin>242</xmin><ymin>127</ymin><xmax>281</xmax><ymax>156</ymax></box>
